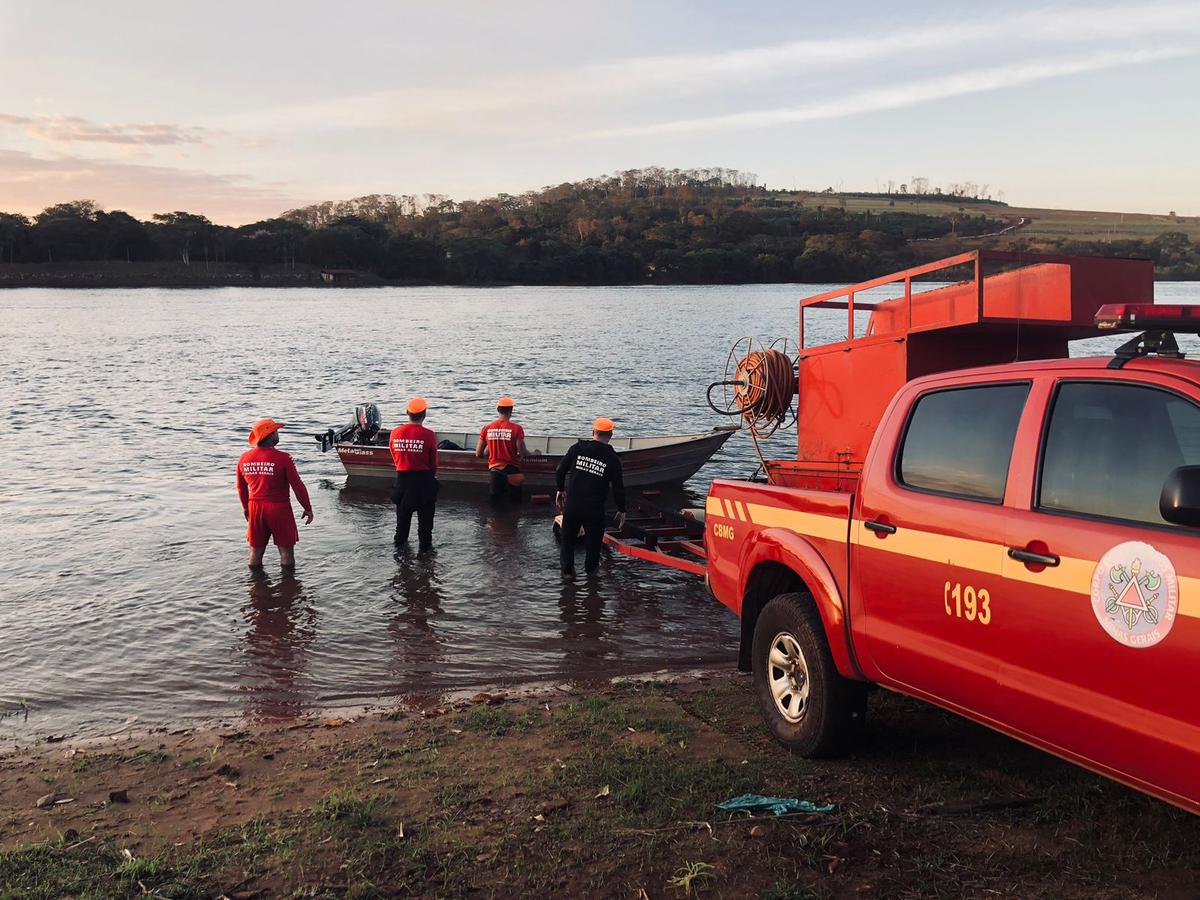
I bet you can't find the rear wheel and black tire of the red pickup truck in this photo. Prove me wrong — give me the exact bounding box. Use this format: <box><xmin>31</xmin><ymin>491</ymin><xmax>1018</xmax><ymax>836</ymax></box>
<box><xmin>751</xmin><ymin>593</ymin><xmax>866</xmax><ymax>757</ymax></box>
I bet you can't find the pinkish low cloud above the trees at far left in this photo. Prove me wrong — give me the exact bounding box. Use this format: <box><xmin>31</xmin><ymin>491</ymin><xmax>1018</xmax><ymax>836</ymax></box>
<box><xmin>0</xmin><ymin>149</ymin><xmax>297</xmax><ymax>224</ymax></box>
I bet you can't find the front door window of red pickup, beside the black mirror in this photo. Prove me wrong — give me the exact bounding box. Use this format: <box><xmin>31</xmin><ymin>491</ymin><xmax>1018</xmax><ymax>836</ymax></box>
<box><xmin>1038</xmin><ymin>382</ymin><xmax>1200</xmax><ymax>527</ymax></box>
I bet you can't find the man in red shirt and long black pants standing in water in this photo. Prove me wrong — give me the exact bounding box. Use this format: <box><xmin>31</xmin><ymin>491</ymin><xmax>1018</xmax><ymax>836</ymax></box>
<box><xmin>388</xmin><ymin>397</ymin><xmax>438</xmax><ymax>553</ymax></box>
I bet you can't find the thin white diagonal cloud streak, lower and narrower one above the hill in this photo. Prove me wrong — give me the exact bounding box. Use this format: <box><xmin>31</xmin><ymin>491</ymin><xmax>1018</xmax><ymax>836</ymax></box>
<box><xmin>578</xmin><ymin>48</ymin><xmax>1196</xmax><ymax>139</ymax></box>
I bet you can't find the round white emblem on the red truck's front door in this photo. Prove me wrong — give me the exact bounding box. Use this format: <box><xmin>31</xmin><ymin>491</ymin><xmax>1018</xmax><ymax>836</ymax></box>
<box><xmin>1092</xmin><ymin>541</ymin><xmax>1180</xmax><ymax>649</ymax></box>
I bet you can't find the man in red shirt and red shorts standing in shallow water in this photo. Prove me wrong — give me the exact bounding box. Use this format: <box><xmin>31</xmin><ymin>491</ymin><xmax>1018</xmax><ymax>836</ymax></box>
<box><xmin>238</xmin><ymin>419</ymin><xmax>312</xmax><ymax>569</ymax></box>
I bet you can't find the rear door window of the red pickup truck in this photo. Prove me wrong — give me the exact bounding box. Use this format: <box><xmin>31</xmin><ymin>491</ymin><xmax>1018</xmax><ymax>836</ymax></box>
<box><xmin>896</xmin><ymin>384</ymin><xmax>1030</xmax><ymax>503</ymax></box>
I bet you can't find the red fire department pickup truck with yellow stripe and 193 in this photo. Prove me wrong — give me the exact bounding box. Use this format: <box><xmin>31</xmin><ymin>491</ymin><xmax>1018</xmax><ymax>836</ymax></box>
<box><xmin>704</xmin><ymin>251</ymin><xmax>1200</xmax><ymax>812</ymax></box>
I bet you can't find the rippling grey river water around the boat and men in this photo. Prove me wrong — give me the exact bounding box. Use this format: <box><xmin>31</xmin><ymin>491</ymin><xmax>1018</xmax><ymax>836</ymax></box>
<box><xmin>0</xmin><ymin>284</ymin><xmax>1200</xmax><ymax>739</ymax></box>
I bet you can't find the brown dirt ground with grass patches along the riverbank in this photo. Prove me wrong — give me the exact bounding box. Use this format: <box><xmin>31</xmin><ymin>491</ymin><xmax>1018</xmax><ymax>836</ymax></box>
<box><xmin>0</xmin><ymin>676</ymin><xmax>1200</xmax><ymax>900</ymax></box>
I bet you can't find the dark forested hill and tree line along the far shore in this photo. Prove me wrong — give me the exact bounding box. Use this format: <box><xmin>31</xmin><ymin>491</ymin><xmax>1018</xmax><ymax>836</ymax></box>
<box><xmin>0</xmin><ymin>169</ymin><xmax>1200</xmax><ymax>284</ymax></box>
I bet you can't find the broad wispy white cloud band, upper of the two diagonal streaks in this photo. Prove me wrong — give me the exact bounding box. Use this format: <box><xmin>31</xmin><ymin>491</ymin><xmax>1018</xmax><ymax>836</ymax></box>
<box><xmin>229</xmin><ymin>0</ymin><xmax>1200</xmax><ymax>131</ymax></box>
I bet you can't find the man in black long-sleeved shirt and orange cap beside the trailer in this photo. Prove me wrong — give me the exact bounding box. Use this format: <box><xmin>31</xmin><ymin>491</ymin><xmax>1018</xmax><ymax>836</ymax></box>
<box><xmin>554</xmin><ymin>419</ymin><xmax>625</xmax><ymax>578</ymax></box>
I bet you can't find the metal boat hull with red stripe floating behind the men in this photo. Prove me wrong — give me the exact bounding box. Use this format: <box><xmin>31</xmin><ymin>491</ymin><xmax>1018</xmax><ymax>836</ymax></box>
<box><xmin>334</xmin><ymin>427</ymin><xmax>737</xmax><ymax>490</ymax></box>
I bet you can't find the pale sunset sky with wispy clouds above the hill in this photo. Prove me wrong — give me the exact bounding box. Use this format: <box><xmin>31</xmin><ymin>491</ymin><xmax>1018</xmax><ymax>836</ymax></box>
<box><xmin>0</xmin><ymin>0</ymin><xmax>1200</xmax><ymax>224</ymax></box>
